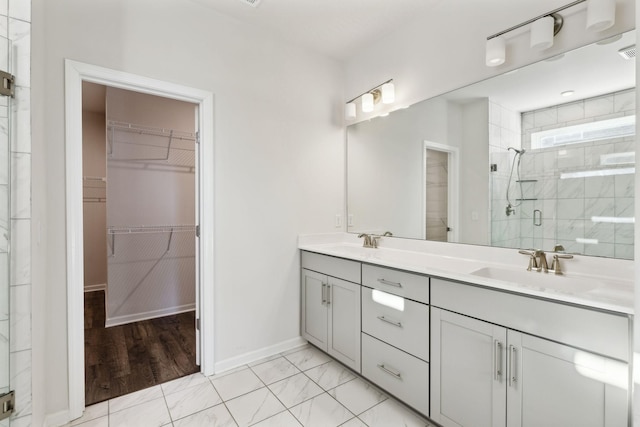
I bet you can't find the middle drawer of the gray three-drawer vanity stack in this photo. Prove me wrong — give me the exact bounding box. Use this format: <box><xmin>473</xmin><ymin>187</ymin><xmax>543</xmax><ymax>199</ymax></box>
<box><xmin>362</xmin><ymin>287</ymin><xmax>429</xmax><ymax>361</ymax></box>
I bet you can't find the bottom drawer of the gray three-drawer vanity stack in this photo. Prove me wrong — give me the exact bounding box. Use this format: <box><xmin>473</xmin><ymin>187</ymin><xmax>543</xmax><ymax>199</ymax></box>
<box><xmin>362</xmin><ymin>333</ymin><xmax>429</xmax><ymax>416</ymax></box>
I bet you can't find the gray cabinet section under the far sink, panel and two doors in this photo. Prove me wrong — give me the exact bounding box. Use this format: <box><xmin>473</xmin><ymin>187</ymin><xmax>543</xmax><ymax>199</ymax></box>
<box><xmin>301</xmin><ymin>252</ymin><xmax>361</xmax><ymax>372</ymax></box>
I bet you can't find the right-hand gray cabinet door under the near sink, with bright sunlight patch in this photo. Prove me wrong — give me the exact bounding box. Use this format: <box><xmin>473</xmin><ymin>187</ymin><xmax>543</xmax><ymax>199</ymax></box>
<box><xmin>507</xmin><ymin>330</ymin><xmax>628</xmax><ymax>427</ymax></box>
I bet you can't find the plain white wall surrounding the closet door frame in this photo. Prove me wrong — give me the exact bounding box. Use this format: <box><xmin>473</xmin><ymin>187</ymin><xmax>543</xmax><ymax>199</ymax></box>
<box><xmin>32</xmin><ymin>0</ymin><xmax>344</xmax><ymax>425</ymax></box>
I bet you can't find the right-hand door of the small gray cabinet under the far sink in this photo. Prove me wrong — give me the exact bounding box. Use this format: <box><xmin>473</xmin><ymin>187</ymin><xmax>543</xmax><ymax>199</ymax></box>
<box><xmin>327</xmin><ymin>277</ymin><xmax>360</xmax><ymax>372</ymax></box>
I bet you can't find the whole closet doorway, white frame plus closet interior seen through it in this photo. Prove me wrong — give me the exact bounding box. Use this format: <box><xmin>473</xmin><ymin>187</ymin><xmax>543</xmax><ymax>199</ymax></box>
<box><xmin>65</xmin><ymin>60</ymin><xmax>214</xmax><ymax>419</ymax></box>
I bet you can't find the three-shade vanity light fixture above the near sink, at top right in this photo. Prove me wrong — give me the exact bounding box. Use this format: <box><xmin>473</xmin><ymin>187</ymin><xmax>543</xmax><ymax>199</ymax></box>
<box><xmin>485</xmin><ymin>0</ymin><xmax>616</xmax><ymax>67</ymax></box>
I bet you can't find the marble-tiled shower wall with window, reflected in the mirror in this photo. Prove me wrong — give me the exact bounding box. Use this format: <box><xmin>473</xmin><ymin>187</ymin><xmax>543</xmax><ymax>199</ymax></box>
<box><xmin>518</xmin><ymin>89</ymin><xmax>636</xmax><ymax>259</ymax></box>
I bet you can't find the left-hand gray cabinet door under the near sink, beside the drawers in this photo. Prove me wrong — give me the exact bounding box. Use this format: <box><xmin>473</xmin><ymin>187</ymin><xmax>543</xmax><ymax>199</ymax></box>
<box><xmin>431</xmin><ymin>307</ymin><xmax>508</xmax><ymax>427</ymax></box>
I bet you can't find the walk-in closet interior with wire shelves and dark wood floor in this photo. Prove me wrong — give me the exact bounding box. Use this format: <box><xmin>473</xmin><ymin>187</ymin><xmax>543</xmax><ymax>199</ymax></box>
<box><xmin>82</xmin><ymin>82</ymin><xmax>199</xmax><ymax>405</ymax></box>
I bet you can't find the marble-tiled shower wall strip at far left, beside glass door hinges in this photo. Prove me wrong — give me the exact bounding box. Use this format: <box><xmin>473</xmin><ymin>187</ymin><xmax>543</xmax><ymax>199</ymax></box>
<box><xmin>0</xmin><ymin>0</ymin><xmax>31</xmax><ymax>427</ymax></box>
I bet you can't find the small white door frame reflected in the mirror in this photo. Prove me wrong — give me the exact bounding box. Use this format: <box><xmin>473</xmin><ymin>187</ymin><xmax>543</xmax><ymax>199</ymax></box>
<box><xmin>422</xmin><ymin>140</ymin><xmax>460</xmax><ymax>242</ymax></box>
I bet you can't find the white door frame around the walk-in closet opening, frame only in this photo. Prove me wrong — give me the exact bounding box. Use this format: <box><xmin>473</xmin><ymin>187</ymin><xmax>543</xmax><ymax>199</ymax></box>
<box><xmin>65</xmin><ymin>59</ymin><xmax>214</xmax><ymax>419</ymax></box>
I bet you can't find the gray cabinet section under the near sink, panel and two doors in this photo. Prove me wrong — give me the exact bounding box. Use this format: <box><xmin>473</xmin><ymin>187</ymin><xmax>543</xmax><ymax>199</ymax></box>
<box><xmin>431</xmin><ymin>279</ymin><xmax>628</xmax><ymax>427</ymax></box>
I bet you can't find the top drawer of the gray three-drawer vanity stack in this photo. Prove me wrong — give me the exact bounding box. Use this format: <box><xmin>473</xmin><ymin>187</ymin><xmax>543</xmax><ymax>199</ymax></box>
<box><xmin>362</xmin><ymin>264</ymin><xmax>429</xmax><ymax>304</ymax></box>
